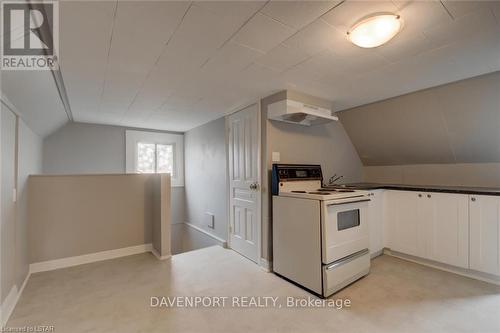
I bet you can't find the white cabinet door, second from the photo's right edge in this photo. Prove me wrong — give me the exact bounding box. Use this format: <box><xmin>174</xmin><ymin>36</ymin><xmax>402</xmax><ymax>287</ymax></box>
<box><xmin>425</xmin><ymin>193</ymin><xmax>469</xmax><ymax>268</ymax></box>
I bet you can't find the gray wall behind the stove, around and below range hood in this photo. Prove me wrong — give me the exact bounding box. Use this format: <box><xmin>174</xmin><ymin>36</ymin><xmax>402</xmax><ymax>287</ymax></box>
<box><xmin>261</xmin><ymin>91</ymin><xmax>363</xmax><ymax>259</ymax></box>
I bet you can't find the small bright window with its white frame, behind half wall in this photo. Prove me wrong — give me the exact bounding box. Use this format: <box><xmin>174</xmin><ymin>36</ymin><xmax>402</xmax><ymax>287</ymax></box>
<box><xmin>125</xmin><ymin>130</ymin><xmax>184</xmax><ymax>186</ymax></box>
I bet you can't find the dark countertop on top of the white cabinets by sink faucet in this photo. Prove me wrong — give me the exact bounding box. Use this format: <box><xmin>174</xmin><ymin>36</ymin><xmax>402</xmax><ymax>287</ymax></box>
<box><xmin>326</xmin><ymin>183</ymin><xmax>500</xmax><ymax>196</ymax></box>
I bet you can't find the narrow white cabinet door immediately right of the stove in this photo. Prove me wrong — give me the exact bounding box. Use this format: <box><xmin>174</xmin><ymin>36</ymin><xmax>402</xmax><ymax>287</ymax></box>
<box><xmin>368</xmin><ymin>190</ymin><xmax>384</xmax><ymax>254</ymax></box>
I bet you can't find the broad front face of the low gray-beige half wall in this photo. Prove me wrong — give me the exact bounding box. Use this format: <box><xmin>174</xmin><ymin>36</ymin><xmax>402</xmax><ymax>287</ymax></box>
<box><xmin>28</xmin><ymin>174</ymin><xmax>160</xmax><ymax>263</ymax></box>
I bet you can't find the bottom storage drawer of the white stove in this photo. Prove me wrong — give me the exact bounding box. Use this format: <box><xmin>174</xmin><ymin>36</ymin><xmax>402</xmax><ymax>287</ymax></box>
<box><xmin>323</xmin><ymin>249</ymin><xmax>370</xmax><ymax>297</ymax></box>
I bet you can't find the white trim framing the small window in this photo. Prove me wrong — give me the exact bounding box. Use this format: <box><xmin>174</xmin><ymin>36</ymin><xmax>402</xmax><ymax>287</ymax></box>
<box><xmin>125</xmin><ymin>130</ymin><xmax>184</xmax><ymax>187</ymax></box>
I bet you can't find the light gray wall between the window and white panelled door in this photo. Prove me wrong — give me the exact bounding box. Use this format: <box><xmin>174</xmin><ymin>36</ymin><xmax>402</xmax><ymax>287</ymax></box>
<box><xmin>184</xmin><ymin>118</ymin><xmax>228</xmax><ymax>239</ymax></box>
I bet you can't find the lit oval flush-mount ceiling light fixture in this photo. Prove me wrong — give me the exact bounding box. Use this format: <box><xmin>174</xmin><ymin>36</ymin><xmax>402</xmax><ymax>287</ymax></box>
<box><xmin>347</xmin><ymin>14</ymin><xmax>403</xmax><ymax>48</ymax></box>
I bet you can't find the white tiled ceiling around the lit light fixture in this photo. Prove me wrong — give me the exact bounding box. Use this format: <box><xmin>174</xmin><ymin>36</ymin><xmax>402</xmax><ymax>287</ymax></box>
<box><xmin>2</xmin><ymin>0</ymin><xmax>500</xmax><ymax>131</ymax></box>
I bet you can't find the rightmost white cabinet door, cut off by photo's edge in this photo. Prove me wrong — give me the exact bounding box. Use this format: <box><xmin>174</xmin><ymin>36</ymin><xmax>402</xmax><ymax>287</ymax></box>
<box><xmin>469</xmin><ymin>195</ymin><xmax>500</xmax><ymax>275</ymax></box>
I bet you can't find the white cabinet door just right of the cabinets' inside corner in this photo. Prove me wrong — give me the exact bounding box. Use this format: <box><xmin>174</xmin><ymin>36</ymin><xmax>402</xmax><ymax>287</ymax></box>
<box><xmin>387</xmin><ymin>191</ymin><xmax>419</xmax><ymax>256</ymax></box>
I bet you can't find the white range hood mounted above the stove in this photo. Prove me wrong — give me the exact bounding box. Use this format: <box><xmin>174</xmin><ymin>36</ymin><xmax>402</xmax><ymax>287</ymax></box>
<box><xmin>267</xmin><ymin>99</ymin><xmax>339</xmax><ymax>126</ymax></box>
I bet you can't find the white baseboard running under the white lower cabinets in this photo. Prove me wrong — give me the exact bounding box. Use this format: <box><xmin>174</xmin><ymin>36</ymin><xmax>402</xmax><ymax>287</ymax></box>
<box><xmin>383</xmin><ymin>248</ymin><xmax>500</xmax><ymax>285</ymax></box>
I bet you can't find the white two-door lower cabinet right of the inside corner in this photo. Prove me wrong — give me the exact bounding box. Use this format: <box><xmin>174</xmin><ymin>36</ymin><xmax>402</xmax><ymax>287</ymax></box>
<box><xmin>386</xmin><ymin>191</ymin><xmax>469</xmax><ymax>268</ymax></box>
